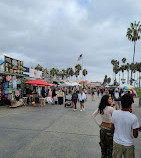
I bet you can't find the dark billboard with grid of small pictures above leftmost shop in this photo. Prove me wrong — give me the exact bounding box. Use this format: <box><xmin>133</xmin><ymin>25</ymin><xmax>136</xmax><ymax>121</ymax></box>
<box><xmin>5</xmin><ymin>56</ymin><xmax>23</xmax><ymax>74</ymax></box>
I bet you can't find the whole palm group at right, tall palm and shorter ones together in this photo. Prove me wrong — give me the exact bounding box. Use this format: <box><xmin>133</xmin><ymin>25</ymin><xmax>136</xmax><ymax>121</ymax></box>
<box><xmin>111</xmin><ymin>21</ymin><xmax>141</xmax><ymax>87</ymax></box>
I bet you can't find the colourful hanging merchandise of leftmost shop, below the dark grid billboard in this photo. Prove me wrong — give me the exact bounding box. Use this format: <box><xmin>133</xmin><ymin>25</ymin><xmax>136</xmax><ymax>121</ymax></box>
<box><xmin>0</xmin><ymin>73</ymin><xmax>23</xmax><ymax>106</ymax></box>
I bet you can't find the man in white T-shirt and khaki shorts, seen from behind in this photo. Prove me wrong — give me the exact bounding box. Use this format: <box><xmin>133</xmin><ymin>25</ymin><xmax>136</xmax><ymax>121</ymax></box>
<box><xmin>112</xmin><ymin>94</ymin><xmax>140</xmax><ymax>158</ymax></box>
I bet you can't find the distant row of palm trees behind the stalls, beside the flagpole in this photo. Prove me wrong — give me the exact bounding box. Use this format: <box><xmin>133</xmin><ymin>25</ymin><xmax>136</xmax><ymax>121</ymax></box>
<box><xmin>35</xmin><ymin>64</ymin><xmax>88</xmax><ymax>80</ymax></box>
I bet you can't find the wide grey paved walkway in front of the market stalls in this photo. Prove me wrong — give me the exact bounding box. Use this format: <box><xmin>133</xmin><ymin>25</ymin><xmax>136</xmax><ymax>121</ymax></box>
<box><xmin>0</xmin><ymin>96</ymin><xmax>141</xmax><ymax>158</ymax></box>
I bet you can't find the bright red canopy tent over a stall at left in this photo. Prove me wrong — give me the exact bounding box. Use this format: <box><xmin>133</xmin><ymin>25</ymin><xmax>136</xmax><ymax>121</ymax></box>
<box><xmin>24</xmin><ymin>79</ymin><xmax>54</xmax><ymax>86</ymax></box>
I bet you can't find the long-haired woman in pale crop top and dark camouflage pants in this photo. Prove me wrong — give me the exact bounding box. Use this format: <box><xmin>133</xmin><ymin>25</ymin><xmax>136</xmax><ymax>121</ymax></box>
<box><xmin>92</xmin><ymin>95</ymin><xmax>115</xmax><ymax>158</ymax></box>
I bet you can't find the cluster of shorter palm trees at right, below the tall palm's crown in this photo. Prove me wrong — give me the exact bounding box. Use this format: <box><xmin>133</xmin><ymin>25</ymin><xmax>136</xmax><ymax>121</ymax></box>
<box><xmin>111</xmin><ymin>58</ymin><xmax>141</xmax><ymax>86</ymax></box>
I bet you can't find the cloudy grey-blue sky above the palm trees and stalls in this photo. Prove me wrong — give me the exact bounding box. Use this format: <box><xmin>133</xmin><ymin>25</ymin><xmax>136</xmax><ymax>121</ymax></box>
<box><xmin>0</xmin><ymin>0</ymin><xmax>141</xmax><ymax>82</ymax></box>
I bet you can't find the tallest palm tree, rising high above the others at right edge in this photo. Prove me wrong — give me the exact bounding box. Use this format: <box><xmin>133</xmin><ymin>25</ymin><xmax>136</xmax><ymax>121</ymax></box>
<box><xmin>126</xmin><ymin>21</ymin><xmax>141</xmax><ymax>85</ymax></box>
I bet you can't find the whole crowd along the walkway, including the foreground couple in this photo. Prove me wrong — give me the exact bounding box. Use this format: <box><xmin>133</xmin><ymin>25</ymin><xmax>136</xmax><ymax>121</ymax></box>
<box><xmin>22</xmin><ymin>84</ymin><xmax>141</xmax><ymax>158</ymax></box>
